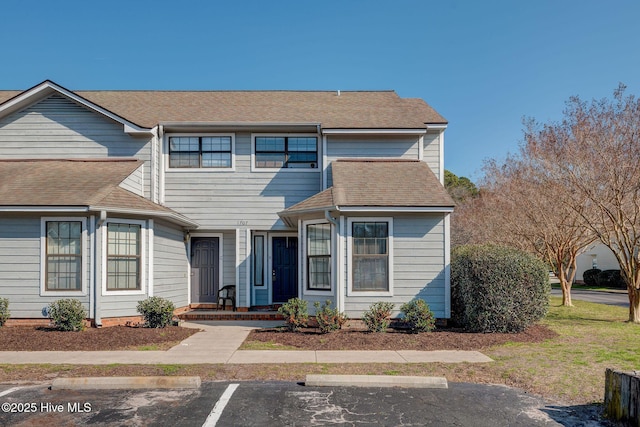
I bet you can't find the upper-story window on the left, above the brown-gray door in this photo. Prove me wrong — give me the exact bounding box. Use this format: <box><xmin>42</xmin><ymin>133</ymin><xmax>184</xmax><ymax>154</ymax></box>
<box><xmin>169</xmin><ymin>135</ymin><xmax>233</xmax><ymax>169</ymax></box>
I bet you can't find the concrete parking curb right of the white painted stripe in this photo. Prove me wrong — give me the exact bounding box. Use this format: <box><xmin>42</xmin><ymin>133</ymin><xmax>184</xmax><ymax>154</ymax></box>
<box><xmin>304</xmin><ymin>375</ymin><xmax>449</xmax><ymax>388</ymax></box>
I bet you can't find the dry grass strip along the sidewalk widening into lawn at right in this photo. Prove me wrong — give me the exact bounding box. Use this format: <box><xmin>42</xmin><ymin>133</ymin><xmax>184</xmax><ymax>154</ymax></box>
<box><xmin>0</xmin><ymin>297</ymin><xmax>640</xmax><ymax>404</ymax></box>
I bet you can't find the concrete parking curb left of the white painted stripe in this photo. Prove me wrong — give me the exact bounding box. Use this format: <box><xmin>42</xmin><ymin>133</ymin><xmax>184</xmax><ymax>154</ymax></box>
<box><xmin>51</xmin><ymin>377</ymin><xmax>201</xmax><ymax>390</ymax></box>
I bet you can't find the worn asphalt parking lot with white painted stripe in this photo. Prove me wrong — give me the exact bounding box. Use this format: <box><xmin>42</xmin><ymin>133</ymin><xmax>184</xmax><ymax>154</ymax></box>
<box><xmin>0</xmin><ymin>382</ymin><xmax>602</xmax><ymax>427</ymax></box>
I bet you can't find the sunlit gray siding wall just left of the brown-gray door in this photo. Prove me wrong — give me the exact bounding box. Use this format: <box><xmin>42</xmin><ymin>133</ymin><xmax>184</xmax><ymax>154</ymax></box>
<box><xmin>153</xmin><ymin>221</ymin><xmax>189</xmax><ymax>308</ymax></box>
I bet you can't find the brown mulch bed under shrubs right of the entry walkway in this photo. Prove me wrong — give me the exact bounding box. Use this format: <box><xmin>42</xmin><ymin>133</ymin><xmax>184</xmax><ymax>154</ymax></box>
<box><xmin>245</xmin><ymin>325</ymin><xmax>558</xmax><ymax>350</ymax></box>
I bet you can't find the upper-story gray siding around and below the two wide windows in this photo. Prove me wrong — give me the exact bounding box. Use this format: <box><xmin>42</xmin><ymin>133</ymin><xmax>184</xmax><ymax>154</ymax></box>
<box><xmin>165</xmin><ymin>133</ymin><xmax>321</xmax><ymax>230</ymax></box>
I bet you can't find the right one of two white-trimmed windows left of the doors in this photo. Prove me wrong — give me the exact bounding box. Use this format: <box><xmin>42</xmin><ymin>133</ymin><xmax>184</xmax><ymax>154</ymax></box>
<box><xmin>107</xmin><ymin>222</ymin><xmax>142</xmax><ymax>291</ymax></box>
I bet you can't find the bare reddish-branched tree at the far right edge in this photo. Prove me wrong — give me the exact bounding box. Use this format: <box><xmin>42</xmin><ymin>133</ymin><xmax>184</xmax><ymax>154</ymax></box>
<box><xmin>525</xmin><ymin>85</ymin><xmax>640</xmax><ymax>323</ymax></box>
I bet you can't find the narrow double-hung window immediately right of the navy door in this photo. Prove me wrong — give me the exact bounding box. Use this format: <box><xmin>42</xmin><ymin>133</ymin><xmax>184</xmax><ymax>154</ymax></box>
<box><xmin>307</xmin><ymin>224</ymin><xmax>331</xmax><ymax>291</ymax></box>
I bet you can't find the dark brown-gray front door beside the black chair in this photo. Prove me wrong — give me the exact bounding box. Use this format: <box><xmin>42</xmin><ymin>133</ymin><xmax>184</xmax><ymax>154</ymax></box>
<box><xmin>191</xmin><ymin>237</ymin><xmax>220</xmax><ymax>303</ymax></box>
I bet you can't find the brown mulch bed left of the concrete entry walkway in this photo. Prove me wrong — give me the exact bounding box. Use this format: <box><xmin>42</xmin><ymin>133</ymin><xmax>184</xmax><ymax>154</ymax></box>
<box><xmin>0</xmin><ymin>326</ymin><xmax>199</xmax><ymax>351</ymax></box>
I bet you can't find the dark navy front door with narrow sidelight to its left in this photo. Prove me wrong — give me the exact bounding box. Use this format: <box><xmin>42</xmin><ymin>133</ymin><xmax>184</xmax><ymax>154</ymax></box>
<box><xmin>271</xmin><ymin>237</ymin><xmax>298</xmax><ymax>303</ymax></box>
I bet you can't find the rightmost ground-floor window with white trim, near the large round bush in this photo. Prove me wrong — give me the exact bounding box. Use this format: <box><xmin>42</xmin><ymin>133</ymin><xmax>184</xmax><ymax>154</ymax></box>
<box><xmin>351</xmin><ymin>220</ymin><xmax>391</xmax><ymax>292</ymax></box>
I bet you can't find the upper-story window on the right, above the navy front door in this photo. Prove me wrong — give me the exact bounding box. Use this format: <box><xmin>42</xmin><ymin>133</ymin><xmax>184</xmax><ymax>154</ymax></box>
<box><xmin>255</xmin><ymin>136</ymin><xmax>318</xmax><ymax>169</ymax></box>
